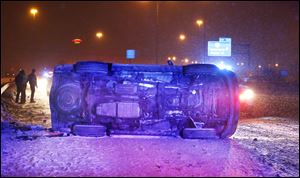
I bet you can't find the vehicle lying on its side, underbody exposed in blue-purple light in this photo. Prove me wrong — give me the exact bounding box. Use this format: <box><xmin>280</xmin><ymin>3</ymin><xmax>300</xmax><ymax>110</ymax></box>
<box><xmin>50</xmin><ymin>61</ymin><xmax>239</xmax><ymax>138</ymax></box>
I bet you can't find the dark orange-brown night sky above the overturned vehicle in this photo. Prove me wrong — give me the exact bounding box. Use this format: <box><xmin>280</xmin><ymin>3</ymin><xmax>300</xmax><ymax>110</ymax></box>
<box><xmin>1</xmin><ymin>1</ymin><xmax>299</xmax><ymax>80</ymax></box>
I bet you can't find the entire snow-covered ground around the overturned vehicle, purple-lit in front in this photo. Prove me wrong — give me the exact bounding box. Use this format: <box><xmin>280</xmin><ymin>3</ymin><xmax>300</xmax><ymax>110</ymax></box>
<box><xmin>1</xmin><ymin>83</ymin><xmax>299</xmax><ymax>176</ymax></box>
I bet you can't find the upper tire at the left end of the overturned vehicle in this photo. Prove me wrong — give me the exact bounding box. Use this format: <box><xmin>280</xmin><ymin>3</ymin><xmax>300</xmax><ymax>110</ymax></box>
<box><xmin>74</xmin><ymin>61</ymin><xmax>108</xmax><ymax>74</ymax></box>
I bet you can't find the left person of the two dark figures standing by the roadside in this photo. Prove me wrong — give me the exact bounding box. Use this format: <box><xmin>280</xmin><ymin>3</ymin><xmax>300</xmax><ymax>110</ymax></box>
<box><xmin>15</xmin><ymin>69</ymin><xmax>27</xmax><ymax>104</ymax></box>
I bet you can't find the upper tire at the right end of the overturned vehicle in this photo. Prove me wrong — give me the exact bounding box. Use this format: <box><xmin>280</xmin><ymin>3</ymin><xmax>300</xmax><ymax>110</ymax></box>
<box><xmin>183</xmin><ymin>64</ymin><xmax>220</xmax><ymax>75</ymax></box>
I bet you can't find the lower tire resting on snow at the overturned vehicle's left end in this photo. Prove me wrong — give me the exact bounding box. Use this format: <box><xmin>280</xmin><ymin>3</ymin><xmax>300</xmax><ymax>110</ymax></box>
<box><xmin>72</xmin><ymin>125</ymin><xmax>106</xmax><ymax>137</ymax></box>
